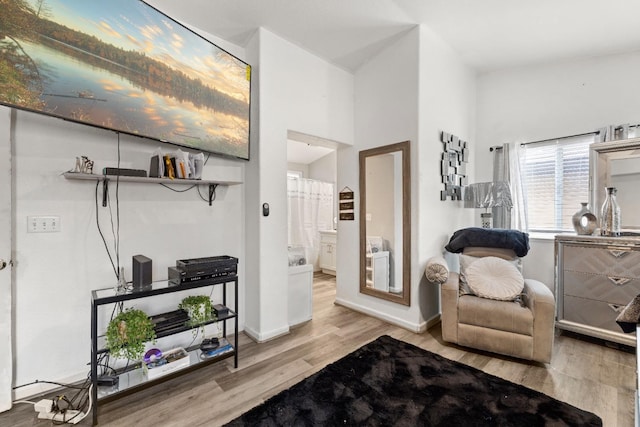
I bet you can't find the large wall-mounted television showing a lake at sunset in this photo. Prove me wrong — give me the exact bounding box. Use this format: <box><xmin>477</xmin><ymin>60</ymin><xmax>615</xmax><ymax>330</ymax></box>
<box><xmin>0</xmin><ymin>0</ymin><xmax>251</xmax><ymax>160</ymax></box>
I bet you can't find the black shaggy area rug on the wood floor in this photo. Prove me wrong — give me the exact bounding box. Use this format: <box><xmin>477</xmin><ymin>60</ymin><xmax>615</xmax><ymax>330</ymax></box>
<box><xmin>227</xmin><ymin>335</ymin><xmax>602</xmax><ymax>427</ymax></box>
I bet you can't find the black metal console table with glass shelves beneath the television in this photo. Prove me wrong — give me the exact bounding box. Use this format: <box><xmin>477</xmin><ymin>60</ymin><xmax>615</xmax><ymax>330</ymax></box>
<box><xmin>91</xmin><ymin>275</ymin><xmax>238</xmax><ymax>425</ymax></box>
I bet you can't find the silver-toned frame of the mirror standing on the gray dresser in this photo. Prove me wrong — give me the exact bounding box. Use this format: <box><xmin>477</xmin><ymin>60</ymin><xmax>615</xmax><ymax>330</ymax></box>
<box><xmin>589</xmin><ymin>138</ymin><xmax>640</xmax><ymax>230</ymax></box>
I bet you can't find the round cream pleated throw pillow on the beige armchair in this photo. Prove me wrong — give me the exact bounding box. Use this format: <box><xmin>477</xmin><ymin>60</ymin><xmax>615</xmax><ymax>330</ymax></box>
<box><xmin>465</xmin><ymin>257</ymin><xmax>524</xmax><ymax>301</ymax></box>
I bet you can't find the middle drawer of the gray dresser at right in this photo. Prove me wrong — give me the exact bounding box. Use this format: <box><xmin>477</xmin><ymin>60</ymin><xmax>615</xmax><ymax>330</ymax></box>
<box><xmin>563</xmin><ymin>270</ymin><xmax>640</xmax><ymax>305</ymax></box>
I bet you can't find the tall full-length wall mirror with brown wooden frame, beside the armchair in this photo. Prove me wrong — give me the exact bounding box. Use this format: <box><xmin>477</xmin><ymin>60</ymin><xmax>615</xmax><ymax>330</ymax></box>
<box><xmin>360</xmin><ymin>141</ymin><xmax>411</xmax><ymax>305</ymax></box>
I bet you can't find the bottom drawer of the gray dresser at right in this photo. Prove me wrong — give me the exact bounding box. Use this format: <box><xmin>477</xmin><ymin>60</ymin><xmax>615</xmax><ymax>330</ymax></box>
<box><xmin>564</xmin><ymin>296</ymin><xmax>625</xmax><ymax>333</ymax></box>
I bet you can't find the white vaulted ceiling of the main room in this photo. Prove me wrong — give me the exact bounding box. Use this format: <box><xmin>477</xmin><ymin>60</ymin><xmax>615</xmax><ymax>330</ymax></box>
<box><xmin>147</xmin><ymin>0</ymin><xmax>640</xmax><ymax>72</ymax></box>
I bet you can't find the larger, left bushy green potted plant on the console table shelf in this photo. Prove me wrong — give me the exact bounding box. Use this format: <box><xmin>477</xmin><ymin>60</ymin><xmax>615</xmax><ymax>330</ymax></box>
<box><xmin>105</xmin><ymin>308</ymin><xmax>156</xmax><ymax>360</ymax></box>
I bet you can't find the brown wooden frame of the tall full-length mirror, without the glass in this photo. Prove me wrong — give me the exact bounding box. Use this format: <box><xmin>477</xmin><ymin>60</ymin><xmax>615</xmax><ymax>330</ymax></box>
<box><xmin>359</xmin><ymin>141</ymin><xmax>411</xmax><ymax>306</ymax></box>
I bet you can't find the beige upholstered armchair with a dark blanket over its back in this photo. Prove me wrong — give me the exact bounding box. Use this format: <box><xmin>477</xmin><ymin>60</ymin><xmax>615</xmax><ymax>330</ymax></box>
<box><xmin>432</xmin><ymin>229</ymin><xmax>555</xmax><ymax>363</ymax></box>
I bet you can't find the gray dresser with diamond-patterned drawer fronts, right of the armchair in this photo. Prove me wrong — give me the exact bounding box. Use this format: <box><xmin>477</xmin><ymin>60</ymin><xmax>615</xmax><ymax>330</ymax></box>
<box><xmin>555</xmin><ymin>235</ymin><xmax>640</xmax><ymax>346</ymax></box>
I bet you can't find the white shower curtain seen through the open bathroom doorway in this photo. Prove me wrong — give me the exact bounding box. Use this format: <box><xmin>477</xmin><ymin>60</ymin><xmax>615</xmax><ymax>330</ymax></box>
<box><xmin>287</xmin><ymin>177</ymin><xmax>333</xmax><ymax>270</ymax></box>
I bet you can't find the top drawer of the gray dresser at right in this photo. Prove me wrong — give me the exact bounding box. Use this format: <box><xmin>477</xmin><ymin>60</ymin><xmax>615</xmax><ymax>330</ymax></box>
<box><xmin>562</xmin><ymin>245</ymin><xmax>640</xmax><ymax>277</ymax></box>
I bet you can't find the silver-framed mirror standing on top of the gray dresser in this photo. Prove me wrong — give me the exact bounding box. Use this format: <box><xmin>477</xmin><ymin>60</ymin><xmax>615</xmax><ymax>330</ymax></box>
<box><xmin>590</xmin><ymin>138</ymin><xmax>640</xmax><ymax>233</ymax></box>
